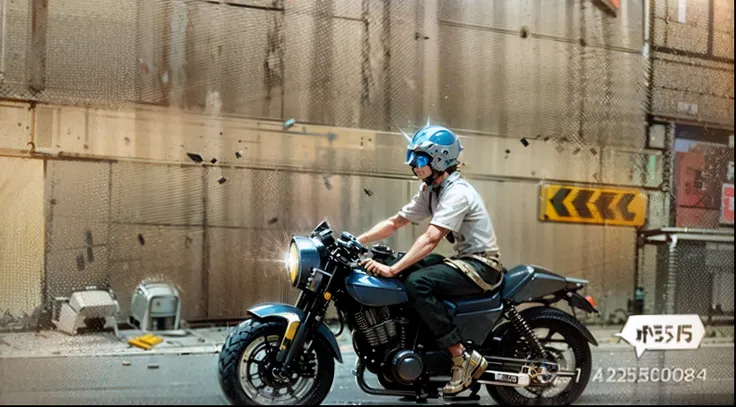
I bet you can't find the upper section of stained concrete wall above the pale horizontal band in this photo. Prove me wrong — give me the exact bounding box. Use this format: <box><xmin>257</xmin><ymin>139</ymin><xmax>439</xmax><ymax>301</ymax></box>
<box><xmin>0</xmin><ymin>0</ymin><xmax>648</xmax><ymax>148</ymax></box>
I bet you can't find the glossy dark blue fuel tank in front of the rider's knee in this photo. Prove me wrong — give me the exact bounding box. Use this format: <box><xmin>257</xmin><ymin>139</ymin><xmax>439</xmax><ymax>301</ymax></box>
<box><xmin>345</xmin><ymin>268</ymin><xmax>409</xmax><ymax>307</ymax></box>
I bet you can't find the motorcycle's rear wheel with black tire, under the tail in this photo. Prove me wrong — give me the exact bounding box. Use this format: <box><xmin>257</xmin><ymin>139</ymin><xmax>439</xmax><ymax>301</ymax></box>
<box><xmin>486</xmin><ymin>309</ymin><xmax>592</xmax><ymax>405</ymax></box>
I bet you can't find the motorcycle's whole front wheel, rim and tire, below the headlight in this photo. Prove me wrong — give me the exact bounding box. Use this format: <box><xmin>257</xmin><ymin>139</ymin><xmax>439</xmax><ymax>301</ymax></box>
<box><xmin>217</xmin><ymin>320</ymin><xmax>335</xmax><ymax>405</ymax></box>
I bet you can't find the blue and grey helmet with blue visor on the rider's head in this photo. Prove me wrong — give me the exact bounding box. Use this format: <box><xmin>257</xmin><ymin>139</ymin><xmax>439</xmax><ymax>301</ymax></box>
<box><xmin>401</xmin><ymin>123</ymin><xmax>463</xmax><ymax>172</ymax></box>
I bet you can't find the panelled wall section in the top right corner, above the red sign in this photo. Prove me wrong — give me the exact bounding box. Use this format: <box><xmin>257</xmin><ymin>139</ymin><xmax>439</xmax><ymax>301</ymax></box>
<box><xmin>652</xmin><ymin>0</ymin><xmax>734</xmax><ymax>128</ymax></box>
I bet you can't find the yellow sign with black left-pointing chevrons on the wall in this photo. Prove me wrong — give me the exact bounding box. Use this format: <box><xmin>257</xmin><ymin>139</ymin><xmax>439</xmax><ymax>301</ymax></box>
<box><xmin>539</xmin><ymin>185</ymin><xmax>648</xmax><ymax>226</ymax></box>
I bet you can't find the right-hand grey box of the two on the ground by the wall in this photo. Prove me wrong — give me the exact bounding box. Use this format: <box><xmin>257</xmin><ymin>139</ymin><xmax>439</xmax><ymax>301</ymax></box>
<box><xmin>129</xmin><ymin>282</ymin><xmax>181</xmax><ymax>331</ymax></box>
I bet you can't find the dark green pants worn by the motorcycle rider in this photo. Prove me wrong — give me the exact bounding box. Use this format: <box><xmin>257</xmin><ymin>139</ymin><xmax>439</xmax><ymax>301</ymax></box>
<box><xmin>394</xmin><ymin>254</ymin><xmax>502</xmax><ymax>348</ymax></box>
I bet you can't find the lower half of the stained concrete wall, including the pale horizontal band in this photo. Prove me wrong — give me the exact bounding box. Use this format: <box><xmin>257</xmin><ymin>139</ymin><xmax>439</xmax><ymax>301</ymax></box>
<box><xmin>0</xmin><ymin>100</ymin><xmax>663</xmax><ymax>324</ymax></box>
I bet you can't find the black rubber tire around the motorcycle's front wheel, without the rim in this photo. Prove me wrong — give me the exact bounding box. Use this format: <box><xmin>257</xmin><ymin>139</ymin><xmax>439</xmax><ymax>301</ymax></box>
<box><xmin>217</xmin><ymin>320</ymin><xmax>335</xmax><ymax>405</ymax></box>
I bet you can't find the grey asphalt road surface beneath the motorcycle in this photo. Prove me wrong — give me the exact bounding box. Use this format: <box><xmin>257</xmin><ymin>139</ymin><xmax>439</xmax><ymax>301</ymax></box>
<box><xmin>0</xmin><ymin>344</ymin><xmax>734</xmax><ymax>405</ymax></box>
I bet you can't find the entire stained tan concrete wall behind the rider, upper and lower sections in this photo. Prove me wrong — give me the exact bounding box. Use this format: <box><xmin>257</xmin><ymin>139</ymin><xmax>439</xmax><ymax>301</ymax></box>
<box><xmin>0</xmin><ymin>0</ymin><xmax>666</xmax><ymax>326</ymax></box>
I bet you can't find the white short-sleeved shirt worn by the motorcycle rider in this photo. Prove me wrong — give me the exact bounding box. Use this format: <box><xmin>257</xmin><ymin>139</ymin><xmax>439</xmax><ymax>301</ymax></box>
<box><xmin>399</xmin><ymin>172</ymin><xmax>499</xmax><ymax>255</ymax></box>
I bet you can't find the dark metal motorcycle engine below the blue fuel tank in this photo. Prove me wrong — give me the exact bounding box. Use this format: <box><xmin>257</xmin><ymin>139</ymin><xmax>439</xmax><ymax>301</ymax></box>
<box><xmin>354</xmin><ymin>307</ymin><xmax>424</xmax><ymax>384</ymax></box>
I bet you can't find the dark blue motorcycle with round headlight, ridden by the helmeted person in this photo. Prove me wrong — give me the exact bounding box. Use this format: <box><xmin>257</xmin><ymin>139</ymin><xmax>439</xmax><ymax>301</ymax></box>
<box><xmin>218</xmin><ymin>221</ymin><xmax>598</xmax><ymax>405</ymax></box>
